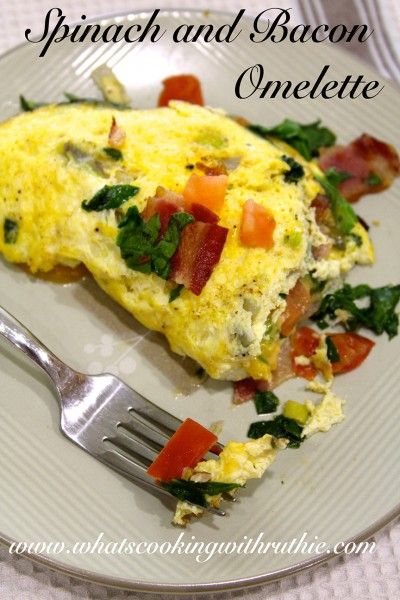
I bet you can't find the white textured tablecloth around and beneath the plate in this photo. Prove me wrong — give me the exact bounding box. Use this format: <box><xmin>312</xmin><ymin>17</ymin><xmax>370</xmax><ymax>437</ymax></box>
<box><xmin>0</xmin><ymin>0</ymin><xmax>400</xmax><ymax>600</ymax></box>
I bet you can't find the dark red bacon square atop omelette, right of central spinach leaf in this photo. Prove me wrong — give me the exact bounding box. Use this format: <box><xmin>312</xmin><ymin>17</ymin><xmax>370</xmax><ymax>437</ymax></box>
<box><xmin>170</xmin><ymin>221</ymin><xmax>228</xmax><ymax>296</ymax></box>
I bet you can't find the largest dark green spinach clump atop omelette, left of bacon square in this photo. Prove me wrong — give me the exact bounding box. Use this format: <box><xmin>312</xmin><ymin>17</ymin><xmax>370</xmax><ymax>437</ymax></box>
<box><xmin>117</xmin><ymin>206</ymin><xmax>194</xmax><ymax>279</ymax></box>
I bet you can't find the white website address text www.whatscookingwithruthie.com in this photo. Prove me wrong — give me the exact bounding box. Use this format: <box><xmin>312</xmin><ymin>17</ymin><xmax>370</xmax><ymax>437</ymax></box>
<box><xmin>9</xmin><ymin>531</ymin><xmax>376</xmax><ymax>563</ymax></box>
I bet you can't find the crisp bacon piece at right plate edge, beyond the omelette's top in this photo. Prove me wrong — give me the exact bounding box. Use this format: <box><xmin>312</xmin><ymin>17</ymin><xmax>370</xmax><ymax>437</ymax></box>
<box><xmin>319</xmin><ymin>133</ymin><xmax>400</xmax><ymax>202</ymax></box>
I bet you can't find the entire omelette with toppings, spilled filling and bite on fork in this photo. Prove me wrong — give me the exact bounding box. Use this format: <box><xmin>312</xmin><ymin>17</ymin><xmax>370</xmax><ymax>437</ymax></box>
<box><xmin>0</xmin><ymin>69</ymin><xmax>400</xmax><ymax>524</ymax></box>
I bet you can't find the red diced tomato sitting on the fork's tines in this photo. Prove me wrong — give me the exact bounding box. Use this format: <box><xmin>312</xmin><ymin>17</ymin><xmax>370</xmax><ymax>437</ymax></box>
<box><xmin>147</xmin><ymin>419</ymin><xmax>218</xmax><ymax>481</ymax></box>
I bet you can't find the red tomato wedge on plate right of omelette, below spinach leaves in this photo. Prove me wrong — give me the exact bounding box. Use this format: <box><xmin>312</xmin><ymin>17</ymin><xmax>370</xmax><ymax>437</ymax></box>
<box><xmin>327</xmin><ymin>332</ymin><xmax>375</xmax><ymax>375</ymax></box>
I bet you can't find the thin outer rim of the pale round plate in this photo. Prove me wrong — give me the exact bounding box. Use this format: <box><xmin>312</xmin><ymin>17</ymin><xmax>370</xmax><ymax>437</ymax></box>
<box><xmin>0</xmin><ymin>7</ymin><xmax>400</xmax><ymax>594</ymax></box>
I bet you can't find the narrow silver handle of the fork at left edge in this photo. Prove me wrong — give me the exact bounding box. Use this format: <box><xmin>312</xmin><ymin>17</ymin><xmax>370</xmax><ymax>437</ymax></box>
<box><xmin>0</xmin><ymin>306</ymin><xmax>73</xmax><ymax>386</ymax></box>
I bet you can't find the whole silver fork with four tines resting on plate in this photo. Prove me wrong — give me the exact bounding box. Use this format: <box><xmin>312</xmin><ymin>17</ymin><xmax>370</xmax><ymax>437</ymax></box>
<box><xmin>0</xmin><ymin>307</ymin><xmax>226</xmax><ymax>516</ymax></box>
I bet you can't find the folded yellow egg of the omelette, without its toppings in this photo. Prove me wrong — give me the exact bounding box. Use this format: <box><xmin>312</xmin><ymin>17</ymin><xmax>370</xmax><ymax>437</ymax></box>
<box><xmin>0</xmin><ymin>102</ymin><xmax>373</xmax><ymax>381</ymax></box>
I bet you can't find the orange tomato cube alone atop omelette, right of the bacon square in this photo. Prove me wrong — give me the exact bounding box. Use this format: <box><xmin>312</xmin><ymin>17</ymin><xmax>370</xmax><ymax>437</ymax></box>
<box><xmin>240</xmin><ymin>200</ymin><xmax>276</xmax><ymax>250</ymax></box>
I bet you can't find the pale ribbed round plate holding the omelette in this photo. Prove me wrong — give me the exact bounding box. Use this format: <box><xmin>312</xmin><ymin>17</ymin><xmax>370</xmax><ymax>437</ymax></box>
<box><xmin>0</xmin><ymin>11</ymin><xmax>400</xmax><ymax>591</ymax></box>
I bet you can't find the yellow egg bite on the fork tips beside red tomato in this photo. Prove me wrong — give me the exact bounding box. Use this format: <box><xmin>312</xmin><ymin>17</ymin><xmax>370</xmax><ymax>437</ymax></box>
<box><xmin>172</xmin><ymin>434</ymin><xmax>286</xmax><ymax>525</ymax></box>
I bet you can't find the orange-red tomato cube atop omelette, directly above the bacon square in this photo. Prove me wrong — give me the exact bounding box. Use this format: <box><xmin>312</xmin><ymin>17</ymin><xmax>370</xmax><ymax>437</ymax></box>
<box><xmin>183</xmin><ymin>173</ymin><xmax>228</xmax><ymax>213</ymax></box>
